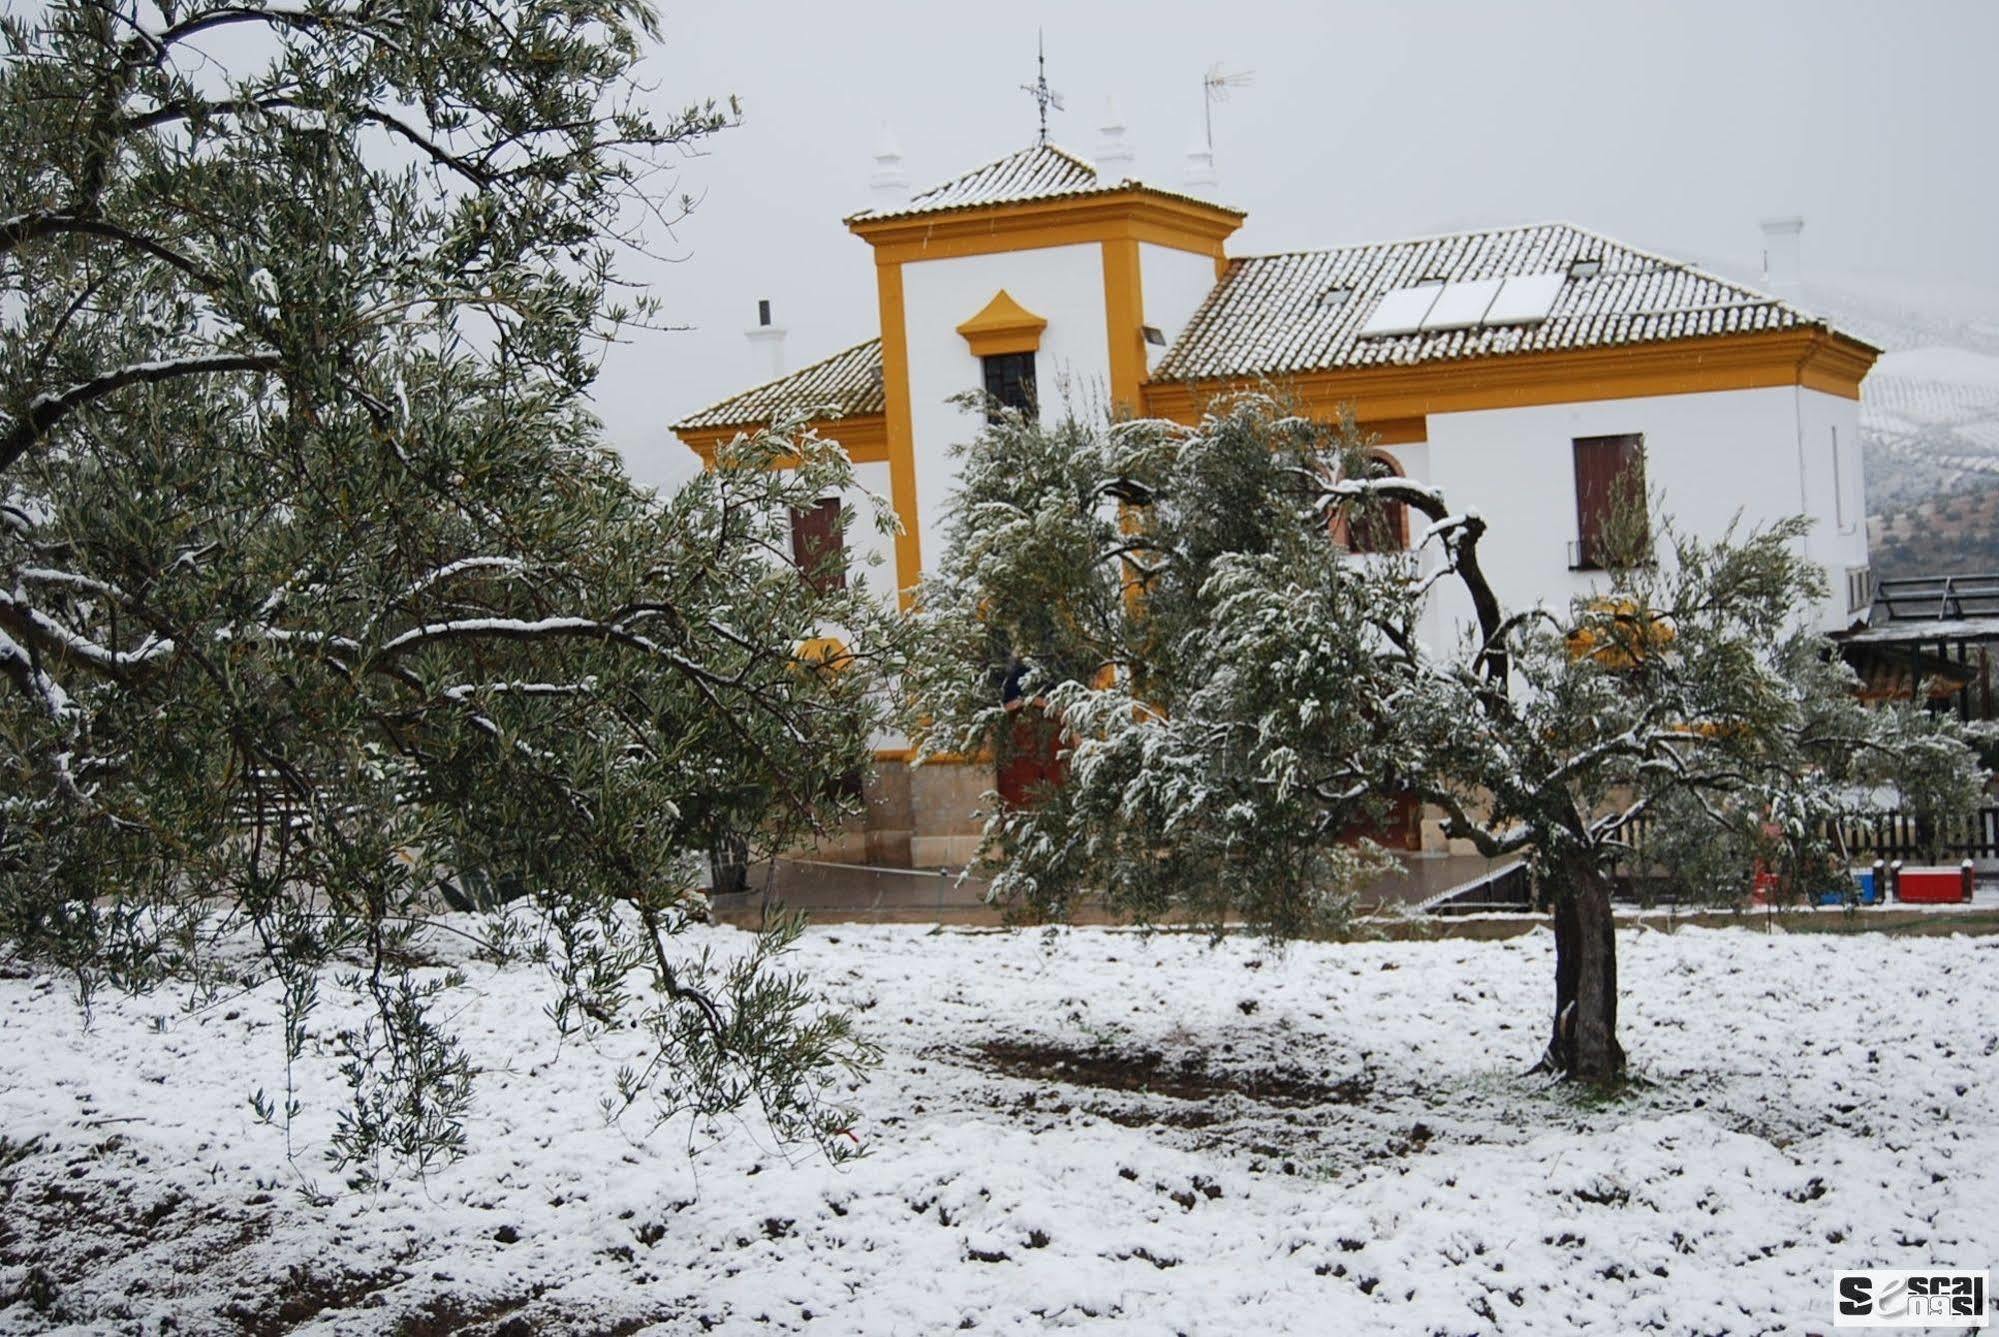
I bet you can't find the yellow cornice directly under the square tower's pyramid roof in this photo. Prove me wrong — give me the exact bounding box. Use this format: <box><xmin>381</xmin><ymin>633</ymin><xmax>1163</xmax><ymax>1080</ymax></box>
<box><xmin>848</xmin><ymin>188</ymin><xmax>1243</xmax><ymax>264</ymax></box>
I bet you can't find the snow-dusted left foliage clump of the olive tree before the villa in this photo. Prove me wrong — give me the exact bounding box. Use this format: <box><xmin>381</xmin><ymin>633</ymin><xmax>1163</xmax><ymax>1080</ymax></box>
<box><xmin>912</xmin><ymin>402</ymin><xmax>1407</xmax><ymax>935</ymax></box>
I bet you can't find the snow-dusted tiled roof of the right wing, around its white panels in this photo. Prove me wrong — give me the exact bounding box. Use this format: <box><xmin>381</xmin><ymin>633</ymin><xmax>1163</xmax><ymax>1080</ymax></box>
<box><xmin>1153</xmin><ymin>222</ymin><xmax>1825</xmax><ymax>380</ymax></box>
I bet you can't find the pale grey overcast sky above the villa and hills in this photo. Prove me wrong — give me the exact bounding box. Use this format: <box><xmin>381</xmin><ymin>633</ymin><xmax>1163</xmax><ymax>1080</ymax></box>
<box><xmin>598</xmin><ymin>0</ymin><xmax>1999</xmax><ymax>482</ymax></box>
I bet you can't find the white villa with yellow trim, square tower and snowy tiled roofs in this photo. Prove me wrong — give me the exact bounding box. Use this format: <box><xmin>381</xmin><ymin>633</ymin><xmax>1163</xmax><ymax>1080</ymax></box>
<box><xmin>676</xmin><ymin>135</ymin><xmax>1877</xmax><ymax>867</ymax></box>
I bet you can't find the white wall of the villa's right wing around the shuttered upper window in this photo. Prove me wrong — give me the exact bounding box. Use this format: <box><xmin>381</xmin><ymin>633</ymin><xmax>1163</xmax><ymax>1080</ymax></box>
<box><xmin>1415</xmin><ymin>386</ymin><xmax>1867</xmax><ymax>646</ymax></box>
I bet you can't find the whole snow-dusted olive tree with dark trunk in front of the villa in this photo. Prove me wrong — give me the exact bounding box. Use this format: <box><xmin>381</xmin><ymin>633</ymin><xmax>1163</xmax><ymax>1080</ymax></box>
<box><xmin>918</xmin><ymin>396</ymin><xmax>1985</xmax><ymax>1081</ymax></box>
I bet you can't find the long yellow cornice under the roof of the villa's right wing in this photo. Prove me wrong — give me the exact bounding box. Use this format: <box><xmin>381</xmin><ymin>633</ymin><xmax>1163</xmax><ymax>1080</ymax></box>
<box><xmin>1145</xmin><ymin>328</ymin><xmax>1879</xmax><ymax>421</ymax></box>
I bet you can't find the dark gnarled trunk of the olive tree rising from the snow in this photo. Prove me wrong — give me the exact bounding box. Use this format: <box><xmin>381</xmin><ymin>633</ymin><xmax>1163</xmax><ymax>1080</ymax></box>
<box><xmin>1541</xmin><ymin>855</ymin><xmax>1625</xmax><ymax>1085</ymax></box>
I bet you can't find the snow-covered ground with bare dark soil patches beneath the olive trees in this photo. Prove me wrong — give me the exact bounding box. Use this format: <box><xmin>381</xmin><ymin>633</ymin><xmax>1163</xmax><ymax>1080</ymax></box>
<box><xmin>0</xmin><ymin>927</ymin><xmax>1999</xmax><ymax>1335</ymax></box>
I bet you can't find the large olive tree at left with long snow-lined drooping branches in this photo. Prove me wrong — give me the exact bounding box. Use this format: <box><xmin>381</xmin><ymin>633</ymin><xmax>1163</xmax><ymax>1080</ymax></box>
<box><xmin>0</xmin><ymin>0</ymin><xmax>898</xmax><ymax>1169</ymax></box>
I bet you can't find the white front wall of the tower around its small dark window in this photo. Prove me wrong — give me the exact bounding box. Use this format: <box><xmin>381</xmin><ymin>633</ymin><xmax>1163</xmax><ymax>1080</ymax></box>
<box><xmin>902</xmin><ymin>242</ymin><xmax>1119</xmax><ymax>570</ymax></box>
